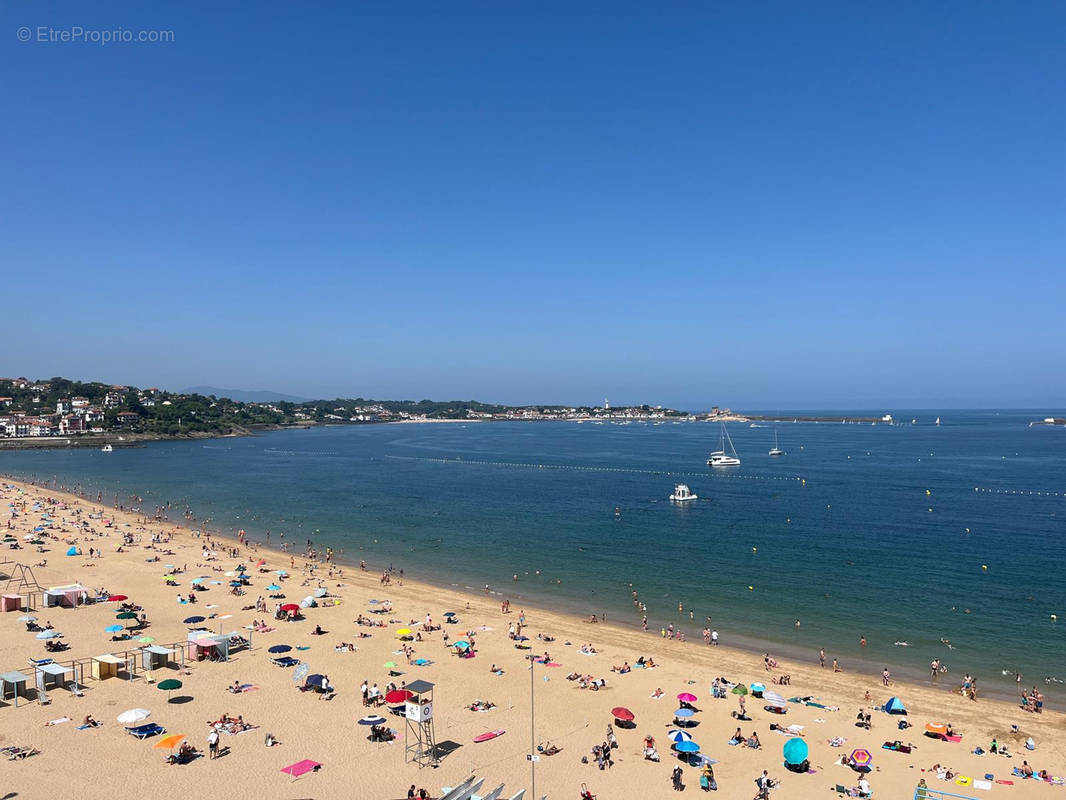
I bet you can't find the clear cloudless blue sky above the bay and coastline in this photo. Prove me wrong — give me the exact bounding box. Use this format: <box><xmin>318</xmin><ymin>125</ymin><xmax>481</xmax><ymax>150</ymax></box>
<box><xmin>0</xmin><ymin>0</ymin><xmax>1066</xmax><ymax>409</ymax></box>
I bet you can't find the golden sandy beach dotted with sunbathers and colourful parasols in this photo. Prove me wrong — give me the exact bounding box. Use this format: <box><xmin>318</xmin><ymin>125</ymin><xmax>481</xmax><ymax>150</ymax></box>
<box><xmin>0</xmin><ymin>481</ymin><xmax>1066</xmax><ymax>800</ymax></box>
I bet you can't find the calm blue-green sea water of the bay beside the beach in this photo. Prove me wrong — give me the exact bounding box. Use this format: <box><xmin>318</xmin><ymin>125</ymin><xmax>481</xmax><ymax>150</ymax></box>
<box><xmin>0</xmin><ymin>412</ymin><xmax>1066</xmax><ymax>706</ymax></box>
